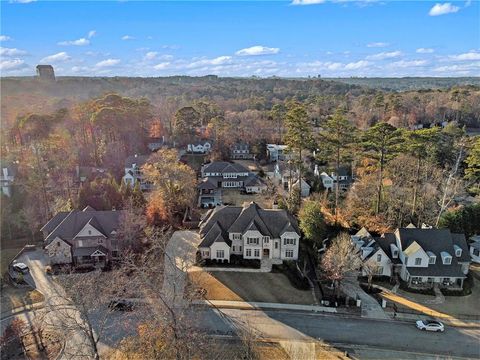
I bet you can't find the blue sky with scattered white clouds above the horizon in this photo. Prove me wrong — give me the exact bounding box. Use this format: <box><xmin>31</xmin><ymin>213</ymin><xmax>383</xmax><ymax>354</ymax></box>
<box><xmin>0</xmin><ymin>0</ymin><xmax>480</xmax><ymax>77</ymax></box>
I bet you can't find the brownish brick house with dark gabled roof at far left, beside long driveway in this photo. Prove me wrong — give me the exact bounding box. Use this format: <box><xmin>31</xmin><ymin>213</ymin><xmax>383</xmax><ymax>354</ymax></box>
<box><xmin>41</xmin><ymin>206</ymin><xmax>122</xmax><ymax>268</ymax></box>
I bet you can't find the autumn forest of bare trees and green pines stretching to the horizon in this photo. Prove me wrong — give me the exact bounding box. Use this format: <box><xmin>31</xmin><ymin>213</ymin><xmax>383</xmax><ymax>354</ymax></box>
<box><xmin>1</xmin><ymin>76</ymin><xmax>480</xmax><ymax>245</ymax></box>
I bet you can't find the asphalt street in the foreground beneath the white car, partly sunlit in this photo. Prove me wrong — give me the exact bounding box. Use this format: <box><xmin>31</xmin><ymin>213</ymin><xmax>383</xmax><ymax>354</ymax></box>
<box><xmin>196</xmin><ymin>309</ymin><xmax>480</xmax><ymax>359</ymax></box>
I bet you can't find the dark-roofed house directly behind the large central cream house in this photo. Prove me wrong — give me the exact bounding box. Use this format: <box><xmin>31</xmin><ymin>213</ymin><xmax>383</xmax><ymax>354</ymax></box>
<box><xmin>197</xmin><ymin>161</ymin><xmax>267</xmax><ymax>207</ymax></box>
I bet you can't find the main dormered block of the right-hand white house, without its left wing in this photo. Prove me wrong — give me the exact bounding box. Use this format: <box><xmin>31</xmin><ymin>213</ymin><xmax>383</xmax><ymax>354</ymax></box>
<box><xmin>394</xmin><ymin>228</ymin><xmax>470</xmax><ymax>289</ymax></box>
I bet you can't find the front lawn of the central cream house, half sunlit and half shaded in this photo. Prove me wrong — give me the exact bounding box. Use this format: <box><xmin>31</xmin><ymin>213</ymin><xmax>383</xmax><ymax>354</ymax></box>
<box><xmin>188</xmin><ymin>271</ymin><xmax>314</xmax><ymax>305</ymax></box>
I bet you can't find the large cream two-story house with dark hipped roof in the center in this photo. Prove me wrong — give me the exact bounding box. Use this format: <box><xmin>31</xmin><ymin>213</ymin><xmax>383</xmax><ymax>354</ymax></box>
<box><xmin>198</xmin><ymin>202</ymin><xmax>300</xmax><ymax>262</ymax></box>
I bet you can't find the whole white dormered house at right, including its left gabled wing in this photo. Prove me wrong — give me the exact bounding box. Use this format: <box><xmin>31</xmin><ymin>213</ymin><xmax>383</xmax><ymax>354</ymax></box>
<box><xmin>352</xmin><ymin>225</ymin><xmax>471</xmax><ymax>289</ymax></box>
